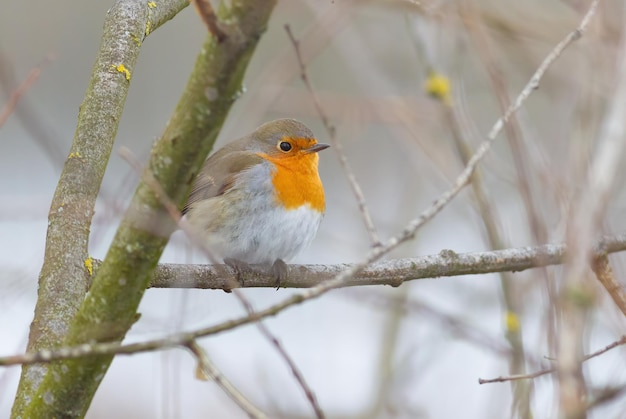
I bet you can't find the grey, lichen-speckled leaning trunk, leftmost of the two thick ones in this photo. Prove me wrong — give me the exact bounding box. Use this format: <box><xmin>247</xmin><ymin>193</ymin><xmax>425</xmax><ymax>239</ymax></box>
<box><xmin>12</xmin><ymin>0</ymin><xmax>188</xmax><ymax>416</ymax></box>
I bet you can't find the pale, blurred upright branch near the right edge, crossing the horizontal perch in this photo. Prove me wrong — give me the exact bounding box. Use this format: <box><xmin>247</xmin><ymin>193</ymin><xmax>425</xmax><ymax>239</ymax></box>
<box><xmin>558</xmin><ymin>0</ymin><xmax>626</xmax><ymax>418</ymax></box>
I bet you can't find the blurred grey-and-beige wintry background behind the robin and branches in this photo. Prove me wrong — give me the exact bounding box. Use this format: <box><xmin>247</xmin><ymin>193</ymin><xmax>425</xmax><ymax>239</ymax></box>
<box><xmin>0</xmin><ymin>0</ymin><xmax>626</xmax><ymax>419</ymax></box>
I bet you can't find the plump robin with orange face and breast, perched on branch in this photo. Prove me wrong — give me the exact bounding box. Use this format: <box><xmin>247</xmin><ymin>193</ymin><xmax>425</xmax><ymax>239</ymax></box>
<box><xmin>183</xmin><ymin>119</ymin><xmax>329</xmax><ymax>285</ymax></box>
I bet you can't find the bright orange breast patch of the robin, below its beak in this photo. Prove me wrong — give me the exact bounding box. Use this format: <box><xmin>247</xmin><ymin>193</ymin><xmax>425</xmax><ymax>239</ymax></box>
<box><xmin>259</xmin><ymin>153</ymin><xmax>326</xmax><ymax>212</ymax></box>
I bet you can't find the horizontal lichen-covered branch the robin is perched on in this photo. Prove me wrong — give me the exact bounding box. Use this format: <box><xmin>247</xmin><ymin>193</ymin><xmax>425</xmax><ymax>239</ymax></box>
<box><xmin>147</xmin><ymin>233</ymin><xmax>626</xmax><ymax>290</ymax></box>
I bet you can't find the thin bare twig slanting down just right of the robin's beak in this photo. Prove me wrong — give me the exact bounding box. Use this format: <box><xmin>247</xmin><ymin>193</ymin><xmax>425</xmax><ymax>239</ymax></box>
<box><xmin>285</xmin><ymin>25</ymin><xmax>382</xmax><ymax>247</ymax></box>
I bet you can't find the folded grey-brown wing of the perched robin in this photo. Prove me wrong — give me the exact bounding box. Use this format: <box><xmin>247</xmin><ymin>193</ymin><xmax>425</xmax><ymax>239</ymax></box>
<box><xmin>183</xmin><ymin>149</ymin><xmax>264</xmax><ymax>214</ymax></box>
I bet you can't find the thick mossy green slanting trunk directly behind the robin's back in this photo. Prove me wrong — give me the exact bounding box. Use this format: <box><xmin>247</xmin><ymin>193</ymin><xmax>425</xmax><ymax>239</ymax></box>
<box><xmin>21</xmin><ymin>0</ymin><xmax>275</xmax><ymax>417</ymax></box>
